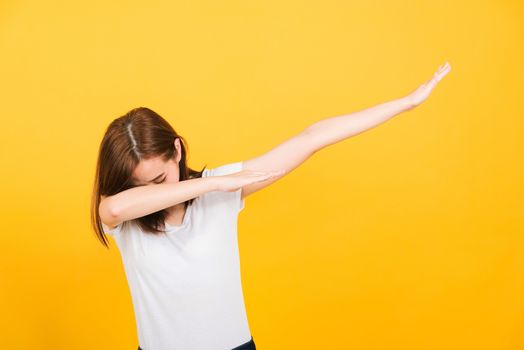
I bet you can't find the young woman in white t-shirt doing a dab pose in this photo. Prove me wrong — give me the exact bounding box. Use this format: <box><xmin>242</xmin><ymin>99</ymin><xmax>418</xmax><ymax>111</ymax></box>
<box><xmin>91</xmin><ymin>62</ymin><xmax>451</xmax><ymax>350</ymax></box>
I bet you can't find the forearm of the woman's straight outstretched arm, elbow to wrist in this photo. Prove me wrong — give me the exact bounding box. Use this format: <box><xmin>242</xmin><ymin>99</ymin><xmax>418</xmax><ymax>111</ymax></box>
<box><xmin>306</xmin><ymin>97</ymin><xmax>413</xmax><ymax>150</ymax></box>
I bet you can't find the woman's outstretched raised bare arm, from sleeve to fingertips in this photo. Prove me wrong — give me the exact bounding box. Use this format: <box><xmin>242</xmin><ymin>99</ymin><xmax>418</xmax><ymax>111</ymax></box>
<box><xmin>242</xmin><ymin>62</ymin><xmax>451</xmax><ymax>198</ymax></box>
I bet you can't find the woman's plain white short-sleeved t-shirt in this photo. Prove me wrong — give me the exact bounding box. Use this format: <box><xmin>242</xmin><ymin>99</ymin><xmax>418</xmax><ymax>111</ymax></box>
<box><xmin>103</xmin><ymin>162</ymin><xmax>251</xmax><ymax>350</ymax></box>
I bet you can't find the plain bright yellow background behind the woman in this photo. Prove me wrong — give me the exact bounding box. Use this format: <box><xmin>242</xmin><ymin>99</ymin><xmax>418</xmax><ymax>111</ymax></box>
<box><xmin>0</xmin><ymin>0</ymin><xmax>524</xmax><ymax>350</ymax></box>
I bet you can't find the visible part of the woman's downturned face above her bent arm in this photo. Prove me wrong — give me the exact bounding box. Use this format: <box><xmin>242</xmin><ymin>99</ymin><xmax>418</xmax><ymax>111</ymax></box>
<box><xmin>132</xmin><ymin>138</ymin><xmax>181</xmax><ymax>186</ymax></box>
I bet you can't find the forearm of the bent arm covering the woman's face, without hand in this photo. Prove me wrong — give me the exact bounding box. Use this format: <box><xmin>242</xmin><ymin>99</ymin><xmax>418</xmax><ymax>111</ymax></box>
<box><xmin>104</xmin><ymin>176</ymin><xmax>217</xmax><ymax>221</ymax></box>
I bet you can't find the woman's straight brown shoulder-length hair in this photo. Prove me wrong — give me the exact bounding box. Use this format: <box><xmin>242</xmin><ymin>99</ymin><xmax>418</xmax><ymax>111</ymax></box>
<box><xmin>91</xmin><ymin>107</ymin><xmax>207</xmax><ymax>247</ymax></box>
